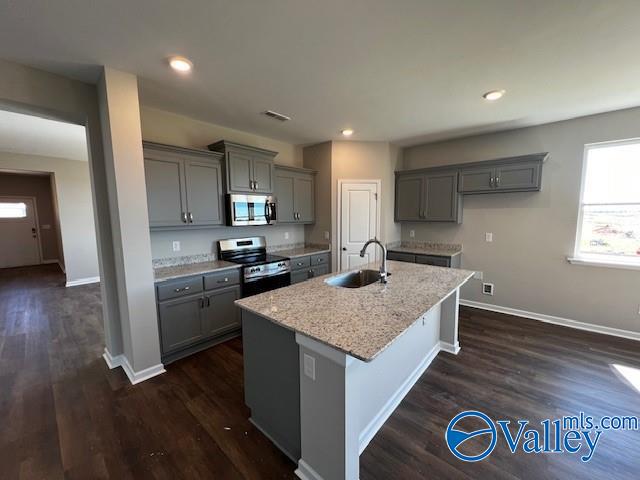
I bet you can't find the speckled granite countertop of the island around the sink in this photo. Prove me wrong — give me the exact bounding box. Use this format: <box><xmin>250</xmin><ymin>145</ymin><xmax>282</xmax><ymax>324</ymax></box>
<box><xmin>236</xmin><ymin>260</ymin><xmax>474</xmax><ymax>362</ymax></box>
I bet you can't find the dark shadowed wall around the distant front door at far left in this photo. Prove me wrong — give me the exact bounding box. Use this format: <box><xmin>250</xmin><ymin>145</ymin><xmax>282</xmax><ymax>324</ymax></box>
<box><xmin>0</xmin><ymin>172</ymin><xmax>61</xmax><ymax>261</ymax></box>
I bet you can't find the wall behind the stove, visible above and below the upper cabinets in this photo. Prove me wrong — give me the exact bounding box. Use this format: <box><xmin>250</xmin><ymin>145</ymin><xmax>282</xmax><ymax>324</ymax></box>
<box><xmin>140</xmin><ymin>107</ymin><xmax>304</xmax><ymax>259</ymax></box>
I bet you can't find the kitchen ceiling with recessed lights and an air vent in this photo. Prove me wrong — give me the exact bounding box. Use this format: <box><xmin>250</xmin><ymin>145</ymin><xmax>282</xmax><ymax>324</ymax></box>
<box><xmin>0</xmin><ymin>0</ymin><xmax>640</xmax><ymax>145</ymax></box>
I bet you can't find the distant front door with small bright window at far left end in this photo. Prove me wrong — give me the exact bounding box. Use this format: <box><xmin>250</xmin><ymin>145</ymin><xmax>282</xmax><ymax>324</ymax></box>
<box><xmin>0</xmin><ymin>197</ymin><xmax>41</xmax><ymax>268</ymax></box>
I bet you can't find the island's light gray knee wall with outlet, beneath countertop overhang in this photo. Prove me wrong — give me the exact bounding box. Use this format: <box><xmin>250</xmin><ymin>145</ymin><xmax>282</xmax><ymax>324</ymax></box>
<box><xmin>296</xmin><ymin>305</ymin><xmax>441</xmax><ymax>480</ymax></box>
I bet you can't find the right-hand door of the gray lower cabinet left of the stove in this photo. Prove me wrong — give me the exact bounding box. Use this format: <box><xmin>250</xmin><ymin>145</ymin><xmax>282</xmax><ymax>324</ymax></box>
<box><xmin>202</xmin><ymin>286</ymin><xmax>241</xmax><ymax>338</ymax></box>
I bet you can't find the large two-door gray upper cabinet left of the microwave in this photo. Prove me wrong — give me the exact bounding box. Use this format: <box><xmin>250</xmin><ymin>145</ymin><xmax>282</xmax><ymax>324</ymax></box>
<box><xmin>143</xmin><ymin>142</ymin><xmax>224</xmax><ymax>229</ymax></box>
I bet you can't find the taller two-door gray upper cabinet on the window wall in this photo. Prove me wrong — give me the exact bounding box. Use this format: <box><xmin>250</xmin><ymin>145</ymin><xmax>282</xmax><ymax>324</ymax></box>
<box><xmin>395</xmin><ymin>170</ymin><xmax>462</xmax><ymax>222</ymax></box>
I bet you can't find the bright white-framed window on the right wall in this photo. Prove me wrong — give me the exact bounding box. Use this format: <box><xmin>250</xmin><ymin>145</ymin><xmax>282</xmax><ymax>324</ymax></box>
<box><xmin>572</xmin><ymin>139</ymin><xmax>640</xmax><ymax>266</ymax></box>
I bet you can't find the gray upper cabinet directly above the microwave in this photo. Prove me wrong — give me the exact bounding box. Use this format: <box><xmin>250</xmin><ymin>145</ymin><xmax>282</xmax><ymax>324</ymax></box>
<box><xmin>209</xmin><ymin>140</ymin><xmax>278</xmax><ymax>193</ymax></box>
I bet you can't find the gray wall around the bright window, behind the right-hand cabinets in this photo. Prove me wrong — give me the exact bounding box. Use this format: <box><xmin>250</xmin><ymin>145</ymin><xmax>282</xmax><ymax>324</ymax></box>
<box><xmin>402</xmin><ymin>108</ymin><xmax>640</xmax><ymax>332</ymax></box>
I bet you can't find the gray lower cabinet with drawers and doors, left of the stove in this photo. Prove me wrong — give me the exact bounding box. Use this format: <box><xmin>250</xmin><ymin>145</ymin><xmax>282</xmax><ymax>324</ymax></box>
<box><xmin>156</xmin><ymin>270</ymin><xmax>241</xmax><ymax>363</ymax></box>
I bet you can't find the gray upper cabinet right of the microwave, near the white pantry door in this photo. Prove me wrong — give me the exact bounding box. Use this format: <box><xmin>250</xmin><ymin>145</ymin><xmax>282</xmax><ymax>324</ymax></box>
<box><xmin>274</xmin><ymin>165</ymin><xmax>315</xmax><ymax>224</ymax></box>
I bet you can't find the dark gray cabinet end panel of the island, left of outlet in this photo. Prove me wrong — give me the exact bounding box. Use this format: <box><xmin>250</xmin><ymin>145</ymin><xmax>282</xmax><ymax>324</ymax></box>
<box><xmin>242</xmin><ymin>309</ymin><xmax>301</xmax><ymax>462</ymax></box>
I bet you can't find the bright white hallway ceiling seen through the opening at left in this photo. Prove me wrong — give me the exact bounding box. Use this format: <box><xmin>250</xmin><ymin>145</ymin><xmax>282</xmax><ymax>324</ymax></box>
<box><xmin>0</xmin><ymin>110</ymin><xmax>88</xmax><ymax>161</ymax></box>
